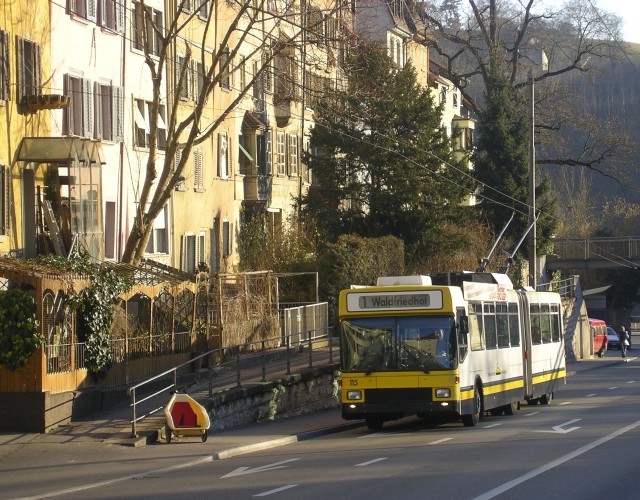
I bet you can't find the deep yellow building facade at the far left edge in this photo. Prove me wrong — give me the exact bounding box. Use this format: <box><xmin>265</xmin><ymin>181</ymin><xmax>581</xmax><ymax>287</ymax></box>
<box><xmin>0</xmin><ymin>0</ymin><xmax>52</xmax><ymax>257</ymax></box>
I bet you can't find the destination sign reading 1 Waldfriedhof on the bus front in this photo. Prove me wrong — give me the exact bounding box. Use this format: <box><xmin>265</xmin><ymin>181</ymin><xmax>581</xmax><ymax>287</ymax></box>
<box><xmin>347</xmin><ymin>290</ymin><xmax>442</xmax><ymax>312</ymax></box>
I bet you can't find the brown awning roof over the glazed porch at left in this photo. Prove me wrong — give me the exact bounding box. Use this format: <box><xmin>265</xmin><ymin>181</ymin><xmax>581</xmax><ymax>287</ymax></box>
<box><xmin>16</xmin><ymin>137</ymin><xmax>106</xmax><ymax>165</ymax></box>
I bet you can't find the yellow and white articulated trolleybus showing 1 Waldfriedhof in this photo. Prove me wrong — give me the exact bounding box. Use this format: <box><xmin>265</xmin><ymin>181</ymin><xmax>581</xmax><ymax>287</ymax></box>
<box><xmin>339</xmin><ymin>272</ymin><xmax>566</xmax><ymax>430</ymax></box>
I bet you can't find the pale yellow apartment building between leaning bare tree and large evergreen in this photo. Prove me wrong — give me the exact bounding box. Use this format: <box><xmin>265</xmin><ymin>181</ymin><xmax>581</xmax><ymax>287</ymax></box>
<box><xmin>167</xmin><ymin>0</ymin><xmax>350</xmax><ymax>272</ymax></box>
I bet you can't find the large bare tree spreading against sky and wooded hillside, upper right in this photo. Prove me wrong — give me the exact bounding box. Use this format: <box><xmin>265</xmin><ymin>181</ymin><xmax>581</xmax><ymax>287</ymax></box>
<box><xmin>423</xmin><ymin>0</ymin><xmax>631</xmax><ymax>179</ymax></box>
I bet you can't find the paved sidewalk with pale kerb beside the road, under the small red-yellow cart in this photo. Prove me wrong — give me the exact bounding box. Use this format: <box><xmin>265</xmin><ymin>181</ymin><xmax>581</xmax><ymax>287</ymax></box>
<box><xmin>0</xmin><ymin>350</ymin><xmax>638</xmax><ymax>462</ymax></box>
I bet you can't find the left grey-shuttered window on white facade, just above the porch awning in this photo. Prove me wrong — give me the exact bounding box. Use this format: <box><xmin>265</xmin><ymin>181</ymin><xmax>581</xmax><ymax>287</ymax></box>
<box><xmin>62</xmin><ymin>75</ymin><xmax>93</xmax><ymax>138</ymax></box>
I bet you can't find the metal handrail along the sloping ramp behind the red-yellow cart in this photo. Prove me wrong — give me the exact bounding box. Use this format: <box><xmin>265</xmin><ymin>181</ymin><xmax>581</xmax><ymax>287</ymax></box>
<box><xmin>127</xmin><ymin>327</ymin><xmax>333</xmax><ymax>438</ymax></box>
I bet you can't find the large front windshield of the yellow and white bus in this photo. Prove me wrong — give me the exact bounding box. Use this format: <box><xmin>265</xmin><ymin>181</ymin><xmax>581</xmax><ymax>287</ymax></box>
<box><xmin>341</xmin><ymin>316</ymin><xmax>456</xmax><ymax>374</ymax></box>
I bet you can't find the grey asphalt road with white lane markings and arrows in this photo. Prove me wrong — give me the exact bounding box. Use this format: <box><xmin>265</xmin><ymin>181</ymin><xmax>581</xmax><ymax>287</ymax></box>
<box><xmin>0</xmin><ymin>351</ymin><xmax>640</xmax><ymax>500</ymax></box>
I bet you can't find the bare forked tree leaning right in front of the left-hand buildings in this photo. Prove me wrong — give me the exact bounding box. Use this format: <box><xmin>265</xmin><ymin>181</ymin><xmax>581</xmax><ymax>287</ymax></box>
<box><xmin>122</xmin><ymin>0</ymin><xmax>342</xmax><ymax>265</ymax></box>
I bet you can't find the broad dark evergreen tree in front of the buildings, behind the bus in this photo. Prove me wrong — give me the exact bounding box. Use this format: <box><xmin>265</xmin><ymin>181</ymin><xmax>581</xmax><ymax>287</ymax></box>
<box><xmin>303</xmin><ymin>43</ymin><xmax>471</xmax><ymax>267</ymax></box>
